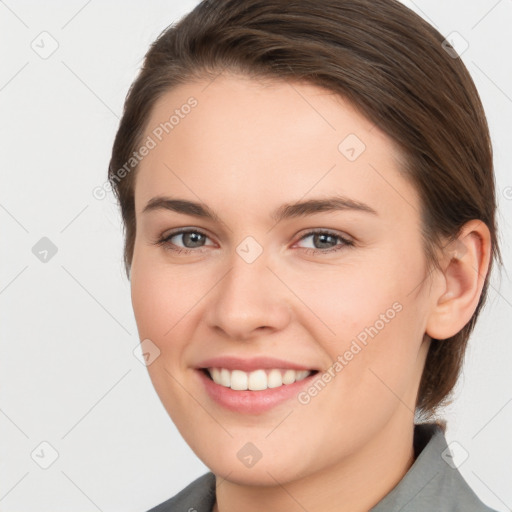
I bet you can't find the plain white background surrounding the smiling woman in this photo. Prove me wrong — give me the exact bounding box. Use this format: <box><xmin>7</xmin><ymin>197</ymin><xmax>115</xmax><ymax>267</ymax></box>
<box><xmin>0</xmin><ymin>0</ymin><xmax>512</xmax><ymax>512</ymax></box>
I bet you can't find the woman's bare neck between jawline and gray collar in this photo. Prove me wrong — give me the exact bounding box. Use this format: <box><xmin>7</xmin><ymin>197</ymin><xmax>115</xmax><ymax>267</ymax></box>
<box><xmin>213</xmin><ymin>415</ymin><xmax>414</xmax><ymax>512</ymax></box>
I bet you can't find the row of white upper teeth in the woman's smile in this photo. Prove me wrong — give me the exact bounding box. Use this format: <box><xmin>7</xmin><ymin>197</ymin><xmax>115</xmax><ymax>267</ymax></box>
<box><xmin>208</xmin><ymin>368</ymin><xmax>312</xmax><ymax>391</ymax></box>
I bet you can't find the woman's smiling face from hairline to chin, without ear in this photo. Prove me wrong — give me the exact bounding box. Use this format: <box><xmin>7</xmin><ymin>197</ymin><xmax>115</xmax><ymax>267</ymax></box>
<box><xmin>131</xmin><ymin>75</ymin><xmax>433</xmax><ymax>485</ymax></box>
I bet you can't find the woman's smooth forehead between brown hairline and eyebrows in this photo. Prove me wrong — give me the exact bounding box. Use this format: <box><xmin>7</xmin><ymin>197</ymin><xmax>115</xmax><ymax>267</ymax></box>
<box><xmin>135</xmin><ymin>75</ymin><xmax>417</xmax><ymax>224</ymax></box>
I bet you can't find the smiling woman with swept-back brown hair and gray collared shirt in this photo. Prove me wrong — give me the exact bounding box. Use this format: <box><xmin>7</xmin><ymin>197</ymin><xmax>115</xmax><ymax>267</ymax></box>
<box><xmin>109</xmin><ymin>0</ymin><xmax>500</xmax><ymax>512</ymax></box>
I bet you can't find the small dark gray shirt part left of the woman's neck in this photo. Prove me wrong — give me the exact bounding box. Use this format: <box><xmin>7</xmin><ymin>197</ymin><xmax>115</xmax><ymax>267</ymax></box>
<box><xmin>144</xmin><ymin>472</ymin><xmax>215</xmax><ymax>512</ymax></box>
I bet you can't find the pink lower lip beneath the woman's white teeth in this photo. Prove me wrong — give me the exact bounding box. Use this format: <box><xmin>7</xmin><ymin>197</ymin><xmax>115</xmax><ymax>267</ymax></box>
<box><xmin>197</xmin><ymin>370</ymin><xmax>317</xmax><ymax>414</ymax></box>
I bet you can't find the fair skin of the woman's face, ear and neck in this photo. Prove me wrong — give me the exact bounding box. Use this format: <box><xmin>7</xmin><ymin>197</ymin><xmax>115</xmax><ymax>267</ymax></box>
<box><xmin>131</xmin><ymin>74</ymin><xmax>490</xmax><ymax>512</ymax></box>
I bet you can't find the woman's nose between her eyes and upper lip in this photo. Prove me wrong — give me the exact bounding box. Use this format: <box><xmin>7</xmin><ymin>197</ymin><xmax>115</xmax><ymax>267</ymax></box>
<box><xmin>206</xmin><ymin>247</ymin><xmax>291</xmax><ymax>341</ymax></box>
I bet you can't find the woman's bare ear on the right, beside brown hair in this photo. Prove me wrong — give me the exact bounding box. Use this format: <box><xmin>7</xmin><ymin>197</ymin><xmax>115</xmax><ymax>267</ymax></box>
<box><xmin>426</xmin><ymin>220</ymin><xmax>491</xmax><ymax>340</ymax></box>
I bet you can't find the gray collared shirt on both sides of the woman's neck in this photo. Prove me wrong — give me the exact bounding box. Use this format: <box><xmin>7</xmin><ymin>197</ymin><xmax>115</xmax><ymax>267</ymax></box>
<box><xmin>148</xmin><ymin>423</ymin><xmax>496</xmax><ymax>512</ymax></box>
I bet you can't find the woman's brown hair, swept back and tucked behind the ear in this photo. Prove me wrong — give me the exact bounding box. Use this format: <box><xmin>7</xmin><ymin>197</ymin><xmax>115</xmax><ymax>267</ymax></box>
<box><xmin>109</xmin><ymin>0</ymin><xmax>502</xmax><ymax>416</ymax></box>
